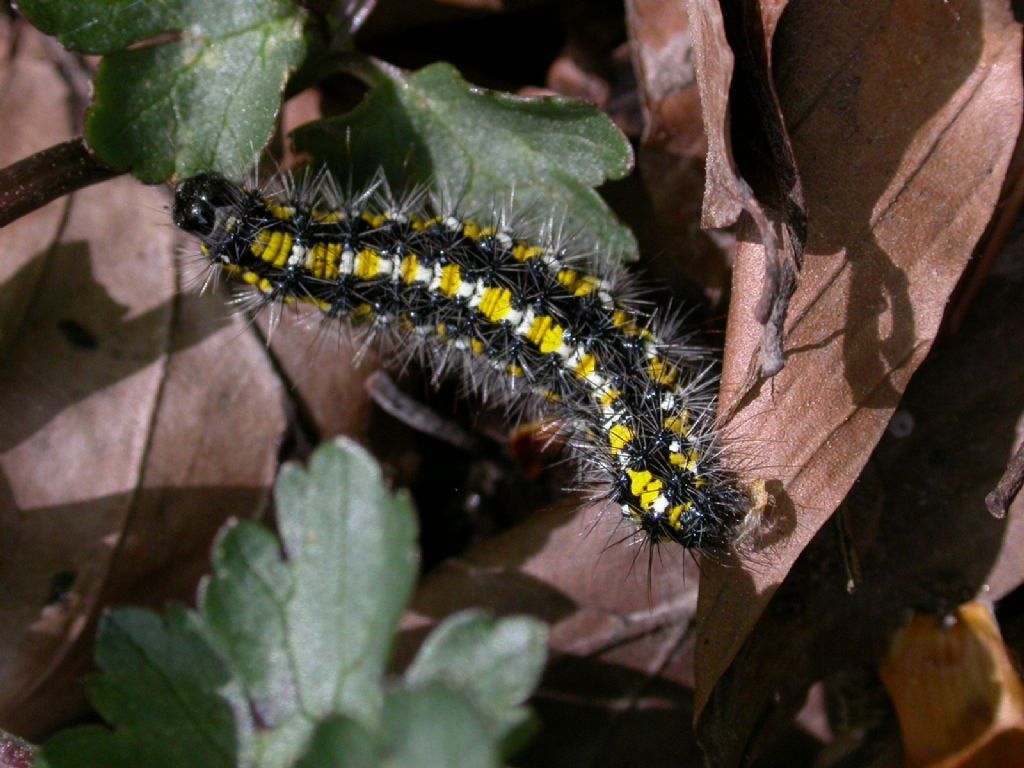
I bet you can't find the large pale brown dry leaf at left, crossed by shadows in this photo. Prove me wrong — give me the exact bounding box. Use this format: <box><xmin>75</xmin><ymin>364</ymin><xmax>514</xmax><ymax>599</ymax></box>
<box><xmin>0</xmin><ymin>20</ymin><xmax>286</xmax><ymax>737</ymax></box>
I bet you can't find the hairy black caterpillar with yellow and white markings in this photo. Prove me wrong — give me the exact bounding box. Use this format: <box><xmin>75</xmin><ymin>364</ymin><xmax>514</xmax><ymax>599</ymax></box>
<box><xmin>173</xmin><ymin>173</ymin><xmax>745</xmax><ymax>552</ymax></box>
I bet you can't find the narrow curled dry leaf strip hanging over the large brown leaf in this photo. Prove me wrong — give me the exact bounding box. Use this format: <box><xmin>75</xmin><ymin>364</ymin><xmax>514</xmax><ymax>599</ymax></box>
<box><xmin>687</xmin><ymin>0</ymin><xmax>807</xmax><ymax>378</ymax></box>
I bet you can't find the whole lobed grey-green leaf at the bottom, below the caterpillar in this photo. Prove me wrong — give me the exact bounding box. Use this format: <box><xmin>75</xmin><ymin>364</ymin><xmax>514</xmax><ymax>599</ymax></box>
<box><xmin>36</xmin><ymin>440</ymin><xmax>545</xmax><ymax>768</ymax></box>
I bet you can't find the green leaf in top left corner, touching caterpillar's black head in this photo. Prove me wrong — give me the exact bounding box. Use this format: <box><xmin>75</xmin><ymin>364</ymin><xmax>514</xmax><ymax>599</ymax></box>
<box><xmin>18</xmin><ymin>0</ymin><xmax>306</xmax><ymax>183</ymax></box>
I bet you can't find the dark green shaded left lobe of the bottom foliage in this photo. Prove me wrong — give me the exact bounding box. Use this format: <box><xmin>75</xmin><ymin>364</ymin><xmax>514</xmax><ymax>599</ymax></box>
<box><xmin>43</xmin><ymin>606</ymin><xmax>238</xmax><ymax>768</ymax></box>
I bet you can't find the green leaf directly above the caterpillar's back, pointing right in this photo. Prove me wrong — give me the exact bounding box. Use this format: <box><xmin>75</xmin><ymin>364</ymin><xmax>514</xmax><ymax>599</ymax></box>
<box><xmin>294</xmin><ymin>63</ymin><xmax>637</xmax><ymax>257</ymax></box>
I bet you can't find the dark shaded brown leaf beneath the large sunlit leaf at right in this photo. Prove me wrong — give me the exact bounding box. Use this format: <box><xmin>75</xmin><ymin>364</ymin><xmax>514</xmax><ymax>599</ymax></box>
<box><xmin>701</xmin><ymin>214</ymin><xmax>1024</xmax><ymax>765</ymax></box>
